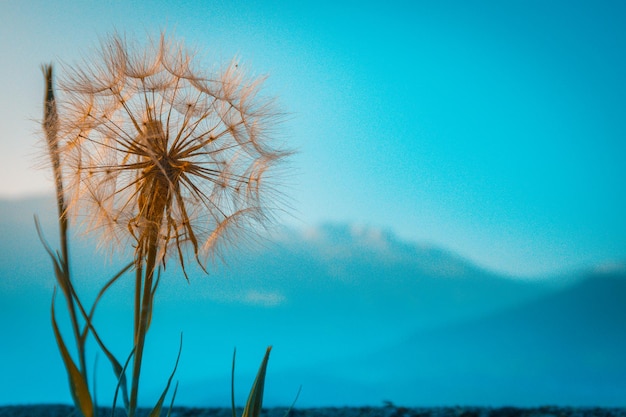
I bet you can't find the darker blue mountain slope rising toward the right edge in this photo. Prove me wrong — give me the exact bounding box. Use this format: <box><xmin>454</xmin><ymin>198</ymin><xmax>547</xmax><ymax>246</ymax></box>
<box><xmin>310</xmin><ymin>271</ymin><xmax>626</xmax><ymax>407</ymax></box>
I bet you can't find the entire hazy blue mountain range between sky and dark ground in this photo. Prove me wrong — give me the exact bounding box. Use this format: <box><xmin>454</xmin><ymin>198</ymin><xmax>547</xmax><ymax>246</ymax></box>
<box><xmin>0</xmin><ymin>198</ymin><xmax>626</xmax><ymax>408</ymax></box>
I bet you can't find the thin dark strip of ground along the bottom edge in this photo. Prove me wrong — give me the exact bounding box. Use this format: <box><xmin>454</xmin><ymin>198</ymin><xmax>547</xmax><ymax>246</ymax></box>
<box><xmin>0</xmin><ymin>405</ymin><xmax>626</xmax><ymax>417</ymax></box>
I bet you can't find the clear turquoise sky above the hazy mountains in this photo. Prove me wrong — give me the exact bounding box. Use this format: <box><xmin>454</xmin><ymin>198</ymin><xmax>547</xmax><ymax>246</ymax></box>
<box><xmin>0</xmin><ymin>1</ymin><xmax>626</xmax><ymax>276</ymax></box>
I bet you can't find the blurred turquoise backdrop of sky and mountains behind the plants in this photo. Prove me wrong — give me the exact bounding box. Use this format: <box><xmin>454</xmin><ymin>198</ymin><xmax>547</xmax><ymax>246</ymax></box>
<box><xmin>0</xmin><ymin>1</ymin><xmax>626</xmax><ymax>406</ymax></box>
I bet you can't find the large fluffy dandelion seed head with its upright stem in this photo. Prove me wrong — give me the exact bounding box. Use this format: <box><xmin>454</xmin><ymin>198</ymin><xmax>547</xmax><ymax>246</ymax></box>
<box><xmin>57</xmin><ymin>34</ymin><xmax>288</xmax><ymax>415</ymax></box>
